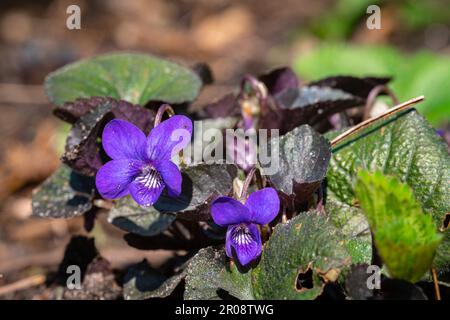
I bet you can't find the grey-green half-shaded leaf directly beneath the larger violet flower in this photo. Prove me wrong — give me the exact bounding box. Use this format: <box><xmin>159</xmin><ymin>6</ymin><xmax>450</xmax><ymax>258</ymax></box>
<box><xmin>108</xmin><ymin>197</ymin><xmax>176</xmax><ymax>237</ymax></box>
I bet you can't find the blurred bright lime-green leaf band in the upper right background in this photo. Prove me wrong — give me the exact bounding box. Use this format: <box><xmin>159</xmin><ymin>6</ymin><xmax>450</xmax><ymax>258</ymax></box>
<box><xmin>294</xmin><ymin>43</ymin><xmax>450</xmax><ymax>126</ymax></box>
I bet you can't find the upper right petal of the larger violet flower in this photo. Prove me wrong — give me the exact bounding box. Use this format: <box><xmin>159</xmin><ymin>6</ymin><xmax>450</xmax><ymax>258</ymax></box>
<box><xmin>147</xmin><ymin>115</ymin><xmax>192</xmax><ymax>161</ymax></box>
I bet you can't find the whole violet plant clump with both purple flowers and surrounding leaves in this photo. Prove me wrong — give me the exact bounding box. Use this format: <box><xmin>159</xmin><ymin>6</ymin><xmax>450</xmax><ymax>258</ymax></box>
<box><xmin>32</xmin><ymin>53</ymin><xmax>450</xmax><ymax>299</ymax></box>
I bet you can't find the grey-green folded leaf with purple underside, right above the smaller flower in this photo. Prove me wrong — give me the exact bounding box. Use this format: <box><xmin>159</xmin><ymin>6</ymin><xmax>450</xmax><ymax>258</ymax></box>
<box><xmin>262</xmin><ymin>125</ymin><xmax>331</xmax><ymax>202</ymax></box>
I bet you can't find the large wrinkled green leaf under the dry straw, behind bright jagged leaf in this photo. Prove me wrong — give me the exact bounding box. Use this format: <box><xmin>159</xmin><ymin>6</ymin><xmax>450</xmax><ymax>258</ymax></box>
<box><xmin>327</xmin><ymin>109</ymin><xmax>450</xmax><ymax>272</ymax></box>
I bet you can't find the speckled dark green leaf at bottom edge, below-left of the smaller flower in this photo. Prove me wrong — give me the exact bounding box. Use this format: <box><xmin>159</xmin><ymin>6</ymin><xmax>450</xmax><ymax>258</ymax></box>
<box><xmin>184</xmin><ymin>247</ymin><xmax>254</xmax><ymax>300</ymax></box>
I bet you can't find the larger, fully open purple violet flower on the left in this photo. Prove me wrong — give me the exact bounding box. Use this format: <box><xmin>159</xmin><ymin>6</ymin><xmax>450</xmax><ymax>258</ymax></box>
<box><xmin>95</xmin><ymin>115</ymin><xmax>192</xmax><ymax>206</ymax></box>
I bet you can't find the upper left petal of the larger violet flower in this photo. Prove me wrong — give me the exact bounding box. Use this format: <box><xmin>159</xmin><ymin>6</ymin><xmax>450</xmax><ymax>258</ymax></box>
<box><xmin>102</xmin><ymin>119</ymin><xmax>147</xmax><ymax>161</ymax></box>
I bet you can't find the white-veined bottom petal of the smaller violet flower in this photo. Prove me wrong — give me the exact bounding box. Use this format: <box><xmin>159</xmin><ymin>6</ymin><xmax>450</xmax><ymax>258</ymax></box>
<box><xmin>225</xmin><ymin>223</ymin><xmax>262</xmax><ymax>266</ymax></box>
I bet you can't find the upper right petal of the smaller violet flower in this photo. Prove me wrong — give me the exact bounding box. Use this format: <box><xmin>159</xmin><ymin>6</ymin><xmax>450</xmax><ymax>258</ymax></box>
<box><xmin>245</xmin><ymin>188</ymin><xmax>280</xmax><ymax>225</ymax></box>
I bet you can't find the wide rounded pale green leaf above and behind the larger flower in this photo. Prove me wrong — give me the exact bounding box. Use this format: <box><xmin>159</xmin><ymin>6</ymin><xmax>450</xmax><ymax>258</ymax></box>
<box><xmin>45</xmin><ymin>53</ymin><xmax>201</xmax><ymax>105</ymax></box>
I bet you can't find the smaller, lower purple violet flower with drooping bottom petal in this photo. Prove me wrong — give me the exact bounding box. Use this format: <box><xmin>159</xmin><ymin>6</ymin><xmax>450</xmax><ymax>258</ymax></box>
<box><xmin>211</xmin><ymin>188</ymin><xmax>280</xmax><ymax>266</ymax></box>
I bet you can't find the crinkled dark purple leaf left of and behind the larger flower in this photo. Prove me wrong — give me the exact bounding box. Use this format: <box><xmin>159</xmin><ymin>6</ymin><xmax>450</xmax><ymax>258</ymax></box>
<box><xmin>62</xmin><ymin>97</ymin><xmax>154</xmax><ymax>176</ymax></box>
